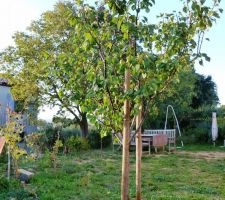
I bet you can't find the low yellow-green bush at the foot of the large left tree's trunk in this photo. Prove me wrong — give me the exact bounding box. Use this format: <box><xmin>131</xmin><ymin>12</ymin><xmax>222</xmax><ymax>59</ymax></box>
<box><xmin>65</xmin><ymin>136</ymin><xmax>90</xmax><ymax>152</ymax></box>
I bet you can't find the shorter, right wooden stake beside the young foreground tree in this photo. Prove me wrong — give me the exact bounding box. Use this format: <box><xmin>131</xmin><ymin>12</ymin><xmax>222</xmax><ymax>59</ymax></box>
<box><xmin>136</xmin><ymin>109</ymin><xmax>142</xmax><ymax>200</ymax></box>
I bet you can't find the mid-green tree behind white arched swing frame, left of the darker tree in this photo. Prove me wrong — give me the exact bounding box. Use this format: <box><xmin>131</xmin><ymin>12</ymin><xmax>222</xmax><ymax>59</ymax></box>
<box><xmin>144</xmin><ymin>66</ymin><xmax>197</xmax><ymax>129</ymax></box>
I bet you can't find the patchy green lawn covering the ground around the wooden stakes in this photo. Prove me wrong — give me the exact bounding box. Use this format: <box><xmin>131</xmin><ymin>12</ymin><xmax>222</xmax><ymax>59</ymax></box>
<box><xmin>0</xmin><ymin>146</ymin><xmax>225</xmax><ymax>200</ymax></box>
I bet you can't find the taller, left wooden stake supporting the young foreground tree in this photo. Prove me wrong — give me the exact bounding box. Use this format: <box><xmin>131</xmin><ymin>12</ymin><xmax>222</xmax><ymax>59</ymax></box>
<box><xmin>121</xmin><ymin>70</ymin><xmax>130</xmax><ymax>200</ymax></box>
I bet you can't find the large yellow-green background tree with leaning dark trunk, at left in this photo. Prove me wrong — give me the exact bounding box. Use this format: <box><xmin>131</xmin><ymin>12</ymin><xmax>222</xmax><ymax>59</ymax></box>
<box><xmin>0</xmin><ymin>2</ymin><xmax>90</xmax><ymax>137</ymax></box>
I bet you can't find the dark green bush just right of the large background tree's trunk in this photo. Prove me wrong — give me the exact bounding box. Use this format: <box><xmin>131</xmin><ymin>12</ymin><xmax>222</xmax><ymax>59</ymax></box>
<box><xmin>88</xmin><ymin>130</ymin><xmax>112</xmax><ymax>149</ymax></box>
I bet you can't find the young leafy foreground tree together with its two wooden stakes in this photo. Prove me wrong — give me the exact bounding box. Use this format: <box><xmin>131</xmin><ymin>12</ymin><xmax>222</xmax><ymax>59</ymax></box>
<box><xmin>68</xmin><ymin>0</ymin><xmax>219</xmax><ymax>199</ymax></box>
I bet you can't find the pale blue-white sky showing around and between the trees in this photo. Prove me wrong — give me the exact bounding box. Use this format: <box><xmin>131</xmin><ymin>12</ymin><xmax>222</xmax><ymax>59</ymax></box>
<box><xmin>0</xmin><ymin>0</ymin><xmax>225</xmax><ymax>121</ymax></box>
